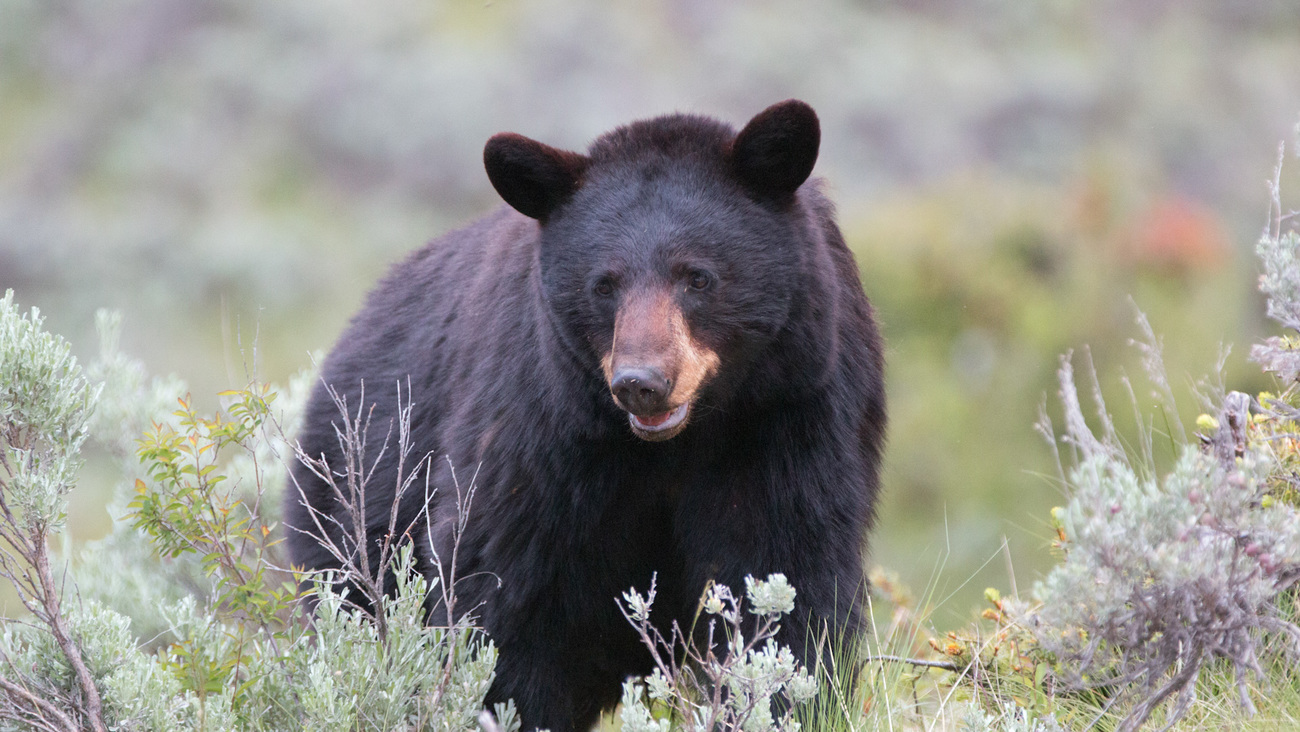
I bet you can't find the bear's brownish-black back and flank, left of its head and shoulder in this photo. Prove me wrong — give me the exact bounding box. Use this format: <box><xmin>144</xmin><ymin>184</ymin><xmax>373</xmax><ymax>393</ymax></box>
<box><xmin>285</xmin><ymin>207</ymin><xmax>548</xmax><ymax>569</ymax></box>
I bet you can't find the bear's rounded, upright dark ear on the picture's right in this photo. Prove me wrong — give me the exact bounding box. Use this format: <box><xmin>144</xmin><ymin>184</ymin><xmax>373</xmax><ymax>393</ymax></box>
<box><xmin>731</xmin><ymin>99</ymin><xmax>822</xmax><ymax>202</ymax></box>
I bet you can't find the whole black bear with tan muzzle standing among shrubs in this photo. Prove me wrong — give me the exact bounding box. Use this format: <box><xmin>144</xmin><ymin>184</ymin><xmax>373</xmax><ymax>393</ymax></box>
<box><xmin>286</xmin><ymin>100</ymin><xmax>885</xmax><ymax>732</ymax></box>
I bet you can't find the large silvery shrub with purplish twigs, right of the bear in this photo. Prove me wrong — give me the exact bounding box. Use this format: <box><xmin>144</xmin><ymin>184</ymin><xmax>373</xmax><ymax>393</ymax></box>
<box><xmin>1031</xmin><ymin>342</ymin><xmax>1300</xmax><ymax>729</ymax></box>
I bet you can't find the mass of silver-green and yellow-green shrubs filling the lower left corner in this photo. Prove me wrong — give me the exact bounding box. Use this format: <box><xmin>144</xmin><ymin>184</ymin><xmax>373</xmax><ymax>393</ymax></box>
<box><xmin>0</xmin><ymin>293</ymin><xmax>501</xmax><ymax>732</ymax></box>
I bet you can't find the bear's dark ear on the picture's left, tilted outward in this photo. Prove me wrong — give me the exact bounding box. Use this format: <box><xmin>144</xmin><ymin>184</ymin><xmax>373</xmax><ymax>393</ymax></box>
<box><xmin>484</xmin><ymin>133</ymin><xmax>588</xmax><ymax>221</ymax></box>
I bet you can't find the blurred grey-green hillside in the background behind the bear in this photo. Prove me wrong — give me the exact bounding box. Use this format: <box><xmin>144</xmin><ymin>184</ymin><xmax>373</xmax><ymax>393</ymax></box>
<box><xmin>0</xmin><ymin>0</ymin><xmax>1300</xmax><ymax>624</ymax></box>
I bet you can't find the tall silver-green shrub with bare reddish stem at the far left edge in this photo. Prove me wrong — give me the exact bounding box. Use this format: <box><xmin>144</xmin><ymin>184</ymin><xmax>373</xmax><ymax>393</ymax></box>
<box><xmin>0</xmin><ymin>290</ymin><xmax>104</xmax><ymax>731</ymax></box>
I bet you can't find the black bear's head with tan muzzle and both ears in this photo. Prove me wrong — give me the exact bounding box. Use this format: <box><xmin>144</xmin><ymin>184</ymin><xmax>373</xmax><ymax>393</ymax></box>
<box><xmin>484</xmin><ymin>100</ymin><xmax>820</xmax><ymax>441</ymax></box>
